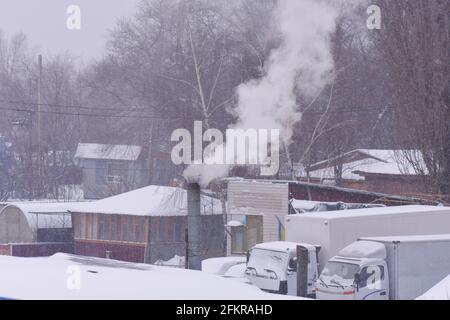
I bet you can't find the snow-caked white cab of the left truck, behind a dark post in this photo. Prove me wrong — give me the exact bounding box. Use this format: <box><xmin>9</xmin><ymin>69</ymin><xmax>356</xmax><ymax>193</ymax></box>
<box><xmin>245</xmin><ymin>241</ymin><xmax>318</xmax><ymax>296</ymax></box>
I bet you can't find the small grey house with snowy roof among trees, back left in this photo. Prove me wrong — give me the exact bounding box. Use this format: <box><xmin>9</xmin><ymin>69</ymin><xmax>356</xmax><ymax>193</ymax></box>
<box><xmin>75</xmin><ymin>143</ymin><xmax>149</xmax><ymax>199</ymax></box>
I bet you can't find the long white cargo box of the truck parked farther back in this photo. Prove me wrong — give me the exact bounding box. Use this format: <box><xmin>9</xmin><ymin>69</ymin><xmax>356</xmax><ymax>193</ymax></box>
<box><xmin>286</xmin><ymin>205</ymin><xmax>450</xmax><ymax>272</ymax></box>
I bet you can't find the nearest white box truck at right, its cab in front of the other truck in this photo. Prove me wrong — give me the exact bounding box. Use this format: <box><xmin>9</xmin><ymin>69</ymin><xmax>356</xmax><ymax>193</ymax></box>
<box><xmin>316</xmin><ymin>235</ymin><xmax>450</xmax><ymax>300</ymax></box>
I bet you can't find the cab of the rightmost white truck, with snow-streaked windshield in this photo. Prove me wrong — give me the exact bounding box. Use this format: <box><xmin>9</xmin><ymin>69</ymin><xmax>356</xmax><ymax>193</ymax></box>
<box><xmin>316</xmin><ymin>241</ymin><xmax>389</xmax><ymax>300</ymax></box>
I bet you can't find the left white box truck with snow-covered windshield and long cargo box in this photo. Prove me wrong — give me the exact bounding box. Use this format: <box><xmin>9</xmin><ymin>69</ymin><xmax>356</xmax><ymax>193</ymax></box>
<box><xmin>246</xmin><ymin>205</ymin><xmax>450</xmax><ymax>295</ymax></box>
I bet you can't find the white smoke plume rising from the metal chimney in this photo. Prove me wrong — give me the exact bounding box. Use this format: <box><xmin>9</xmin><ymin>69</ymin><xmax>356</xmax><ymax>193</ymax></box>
<box><xmin>184</xmin><ymin>0</ymin><xmax>346</xmax><ymax>185</ymax></box>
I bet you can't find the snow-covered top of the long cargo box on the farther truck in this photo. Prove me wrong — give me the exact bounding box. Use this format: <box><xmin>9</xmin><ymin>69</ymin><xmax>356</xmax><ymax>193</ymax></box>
<box><xmin>289</xmin><ymin>205</ymin><xmax>450</xmax><ymax>220</ymax></box>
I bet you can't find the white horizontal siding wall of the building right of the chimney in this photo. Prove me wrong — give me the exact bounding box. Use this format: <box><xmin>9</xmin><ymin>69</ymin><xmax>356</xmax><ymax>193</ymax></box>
<box><xmin>228</xmin><ymin>181</ymin><xmax>289</xmax><ymax>242</ymax></box>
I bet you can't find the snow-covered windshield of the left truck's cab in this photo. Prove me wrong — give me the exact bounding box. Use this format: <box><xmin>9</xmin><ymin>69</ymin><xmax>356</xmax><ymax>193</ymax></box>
<box><xmin>247</xmin><ymin>249</ymin><xmax>288</xmax><ymax>277</ymax></box>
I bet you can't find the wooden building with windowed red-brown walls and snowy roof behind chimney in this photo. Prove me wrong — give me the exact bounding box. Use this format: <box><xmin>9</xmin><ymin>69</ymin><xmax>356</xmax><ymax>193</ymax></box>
<box><xmin>71</xmin><ymin>186</ymin><xmax>225</xmax><ymax>263</ymax></box>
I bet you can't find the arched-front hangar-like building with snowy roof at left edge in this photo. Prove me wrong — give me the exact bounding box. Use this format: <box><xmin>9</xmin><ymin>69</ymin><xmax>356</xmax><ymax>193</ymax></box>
<box><xmin>0</xmin><ymin>202</ymin><xmax>76</xmax><ymax>257</ymax></box>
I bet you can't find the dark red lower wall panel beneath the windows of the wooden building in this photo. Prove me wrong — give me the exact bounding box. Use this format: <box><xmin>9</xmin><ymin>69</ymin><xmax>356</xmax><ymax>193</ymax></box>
<box><xmin>74</xmin><ymin>240</ymin><xmax>145</xmax><ymax>263</ymax></box>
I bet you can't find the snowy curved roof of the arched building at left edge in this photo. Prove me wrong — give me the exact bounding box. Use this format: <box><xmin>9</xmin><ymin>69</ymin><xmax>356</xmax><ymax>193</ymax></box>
<box><xmin>0</xmin><ymin>201</ymin><xmax>83</xmax><ymax>230</ymax></box>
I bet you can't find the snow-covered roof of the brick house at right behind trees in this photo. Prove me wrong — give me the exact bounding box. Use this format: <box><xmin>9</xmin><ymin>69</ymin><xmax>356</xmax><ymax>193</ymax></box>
<box><xmin>309</xmin><ymin>149</ymin><xmax>426</xmax><ymax>180</ymax></box>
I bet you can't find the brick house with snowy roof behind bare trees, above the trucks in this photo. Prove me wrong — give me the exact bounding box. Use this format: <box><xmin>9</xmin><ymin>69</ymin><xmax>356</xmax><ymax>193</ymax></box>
<box><xmin>308</xmin><ymin>149</ymin><xmax>430</xmax><ymax>195</ymax></box>
